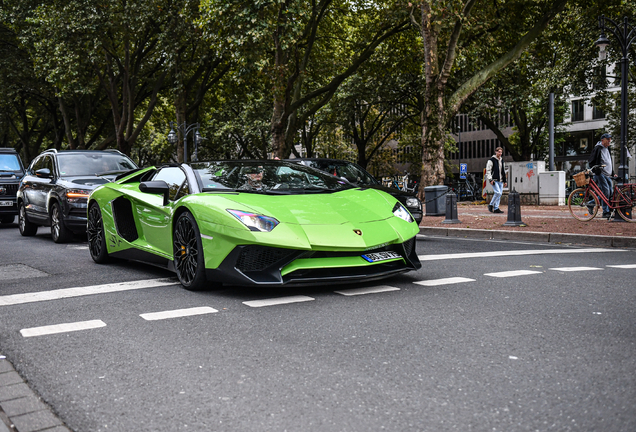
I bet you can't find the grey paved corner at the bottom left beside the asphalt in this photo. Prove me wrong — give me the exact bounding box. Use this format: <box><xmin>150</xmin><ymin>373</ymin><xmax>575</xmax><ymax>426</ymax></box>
<box><xmin>0</xmin><ymin>355</ymin><xmax>71</xmax><ymax>432</ymax></box>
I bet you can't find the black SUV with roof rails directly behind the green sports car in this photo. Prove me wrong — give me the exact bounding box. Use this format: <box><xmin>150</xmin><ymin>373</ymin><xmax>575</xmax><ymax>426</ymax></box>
<box><xmin>18</xmin><ymin>150</ymin><xmax>137</xmax><ymax>243</ymax></box>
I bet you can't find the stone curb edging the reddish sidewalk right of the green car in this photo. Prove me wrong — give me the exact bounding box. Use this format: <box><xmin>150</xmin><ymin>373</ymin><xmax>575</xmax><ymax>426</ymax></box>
<box><xmin>420</xmin><ymin>227</ymin><xmax>636</xmax><ymax>249</ymax></box>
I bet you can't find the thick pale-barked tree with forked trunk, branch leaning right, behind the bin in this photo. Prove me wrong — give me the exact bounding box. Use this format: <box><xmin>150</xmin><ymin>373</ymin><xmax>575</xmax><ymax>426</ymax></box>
<box><xmin>411</xmin><ymin>0</ymin><xmax>567</xmax><ymax>194</ymax></box>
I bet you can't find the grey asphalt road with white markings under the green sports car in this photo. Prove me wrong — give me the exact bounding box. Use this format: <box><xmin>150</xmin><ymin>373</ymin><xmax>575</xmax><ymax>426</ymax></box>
<box><xmin>0</xmin><ymin>223</ymin><xmax>636</xmax><ymax>432</ymax></box>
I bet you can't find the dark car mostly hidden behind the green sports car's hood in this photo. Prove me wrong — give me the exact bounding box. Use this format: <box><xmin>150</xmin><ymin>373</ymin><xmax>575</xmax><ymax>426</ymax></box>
<box><xmin>289</xmin><ymin>158</ymin><xmax>422</xmax><ymax>225</ymax></box>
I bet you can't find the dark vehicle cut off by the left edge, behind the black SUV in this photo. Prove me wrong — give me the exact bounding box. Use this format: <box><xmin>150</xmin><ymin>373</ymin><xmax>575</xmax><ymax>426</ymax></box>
<box><xmin>0</xmin><ymin>148</ymin><xmax>24</xmax><ymax>224</ymax></box>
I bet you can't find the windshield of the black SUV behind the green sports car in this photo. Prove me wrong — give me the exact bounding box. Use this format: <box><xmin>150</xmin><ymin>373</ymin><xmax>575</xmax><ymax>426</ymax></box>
<box><xmin>57</xmin><ymin>152</ymin><xmax>137</xmax><ymax>176</ymax></box>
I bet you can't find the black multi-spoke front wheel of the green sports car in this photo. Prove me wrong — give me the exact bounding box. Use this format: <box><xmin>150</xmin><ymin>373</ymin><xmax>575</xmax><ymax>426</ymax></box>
<box><xmin>172</xmin><ymin>212</ymin><xmax>208</xmax><ymax>291</ymax></box>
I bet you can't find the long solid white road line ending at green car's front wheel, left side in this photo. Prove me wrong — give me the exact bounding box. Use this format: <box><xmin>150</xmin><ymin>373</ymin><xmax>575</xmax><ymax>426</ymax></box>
<box><xmin>0</xmin><ymin>278</ymin><xmax>178</xmax><ymax>306</ymax></box>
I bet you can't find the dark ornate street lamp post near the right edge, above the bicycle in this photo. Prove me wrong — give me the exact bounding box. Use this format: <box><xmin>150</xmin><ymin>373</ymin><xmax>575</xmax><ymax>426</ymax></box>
<box><xmin>596</xmin><ymin>15</ymin><xmax>636</xmax><ymax>184</ymax></box>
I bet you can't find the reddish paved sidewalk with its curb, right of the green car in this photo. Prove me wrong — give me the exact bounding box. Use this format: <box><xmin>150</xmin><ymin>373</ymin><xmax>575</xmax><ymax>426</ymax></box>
<box><xmin>420</xmin><ymin>202</ymin><xmax>636</xmax><ymax>248</ymax></box>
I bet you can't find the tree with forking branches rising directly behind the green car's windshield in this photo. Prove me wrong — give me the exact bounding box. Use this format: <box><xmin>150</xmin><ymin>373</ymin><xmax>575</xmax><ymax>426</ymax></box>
<box><xmin>202</xmin><ymin>0</ymin><xmax>408</xmax><ymax>158</ymax></box>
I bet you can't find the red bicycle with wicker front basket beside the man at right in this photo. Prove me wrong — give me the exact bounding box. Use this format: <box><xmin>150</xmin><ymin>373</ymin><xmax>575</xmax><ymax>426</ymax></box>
<box><xmin>568</xmin><ymin>165</ymin><xmax>636</xmax><ymax>222</ymax></box>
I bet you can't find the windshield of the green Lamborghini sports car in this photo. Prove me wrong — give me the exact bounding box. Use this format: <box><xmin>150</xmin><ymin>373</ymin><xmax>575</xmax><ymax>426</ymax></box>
<box><xmin>191</xmin><ymin>160</ymin><xmax>352</xmax><ymax>194</ymax></box>
